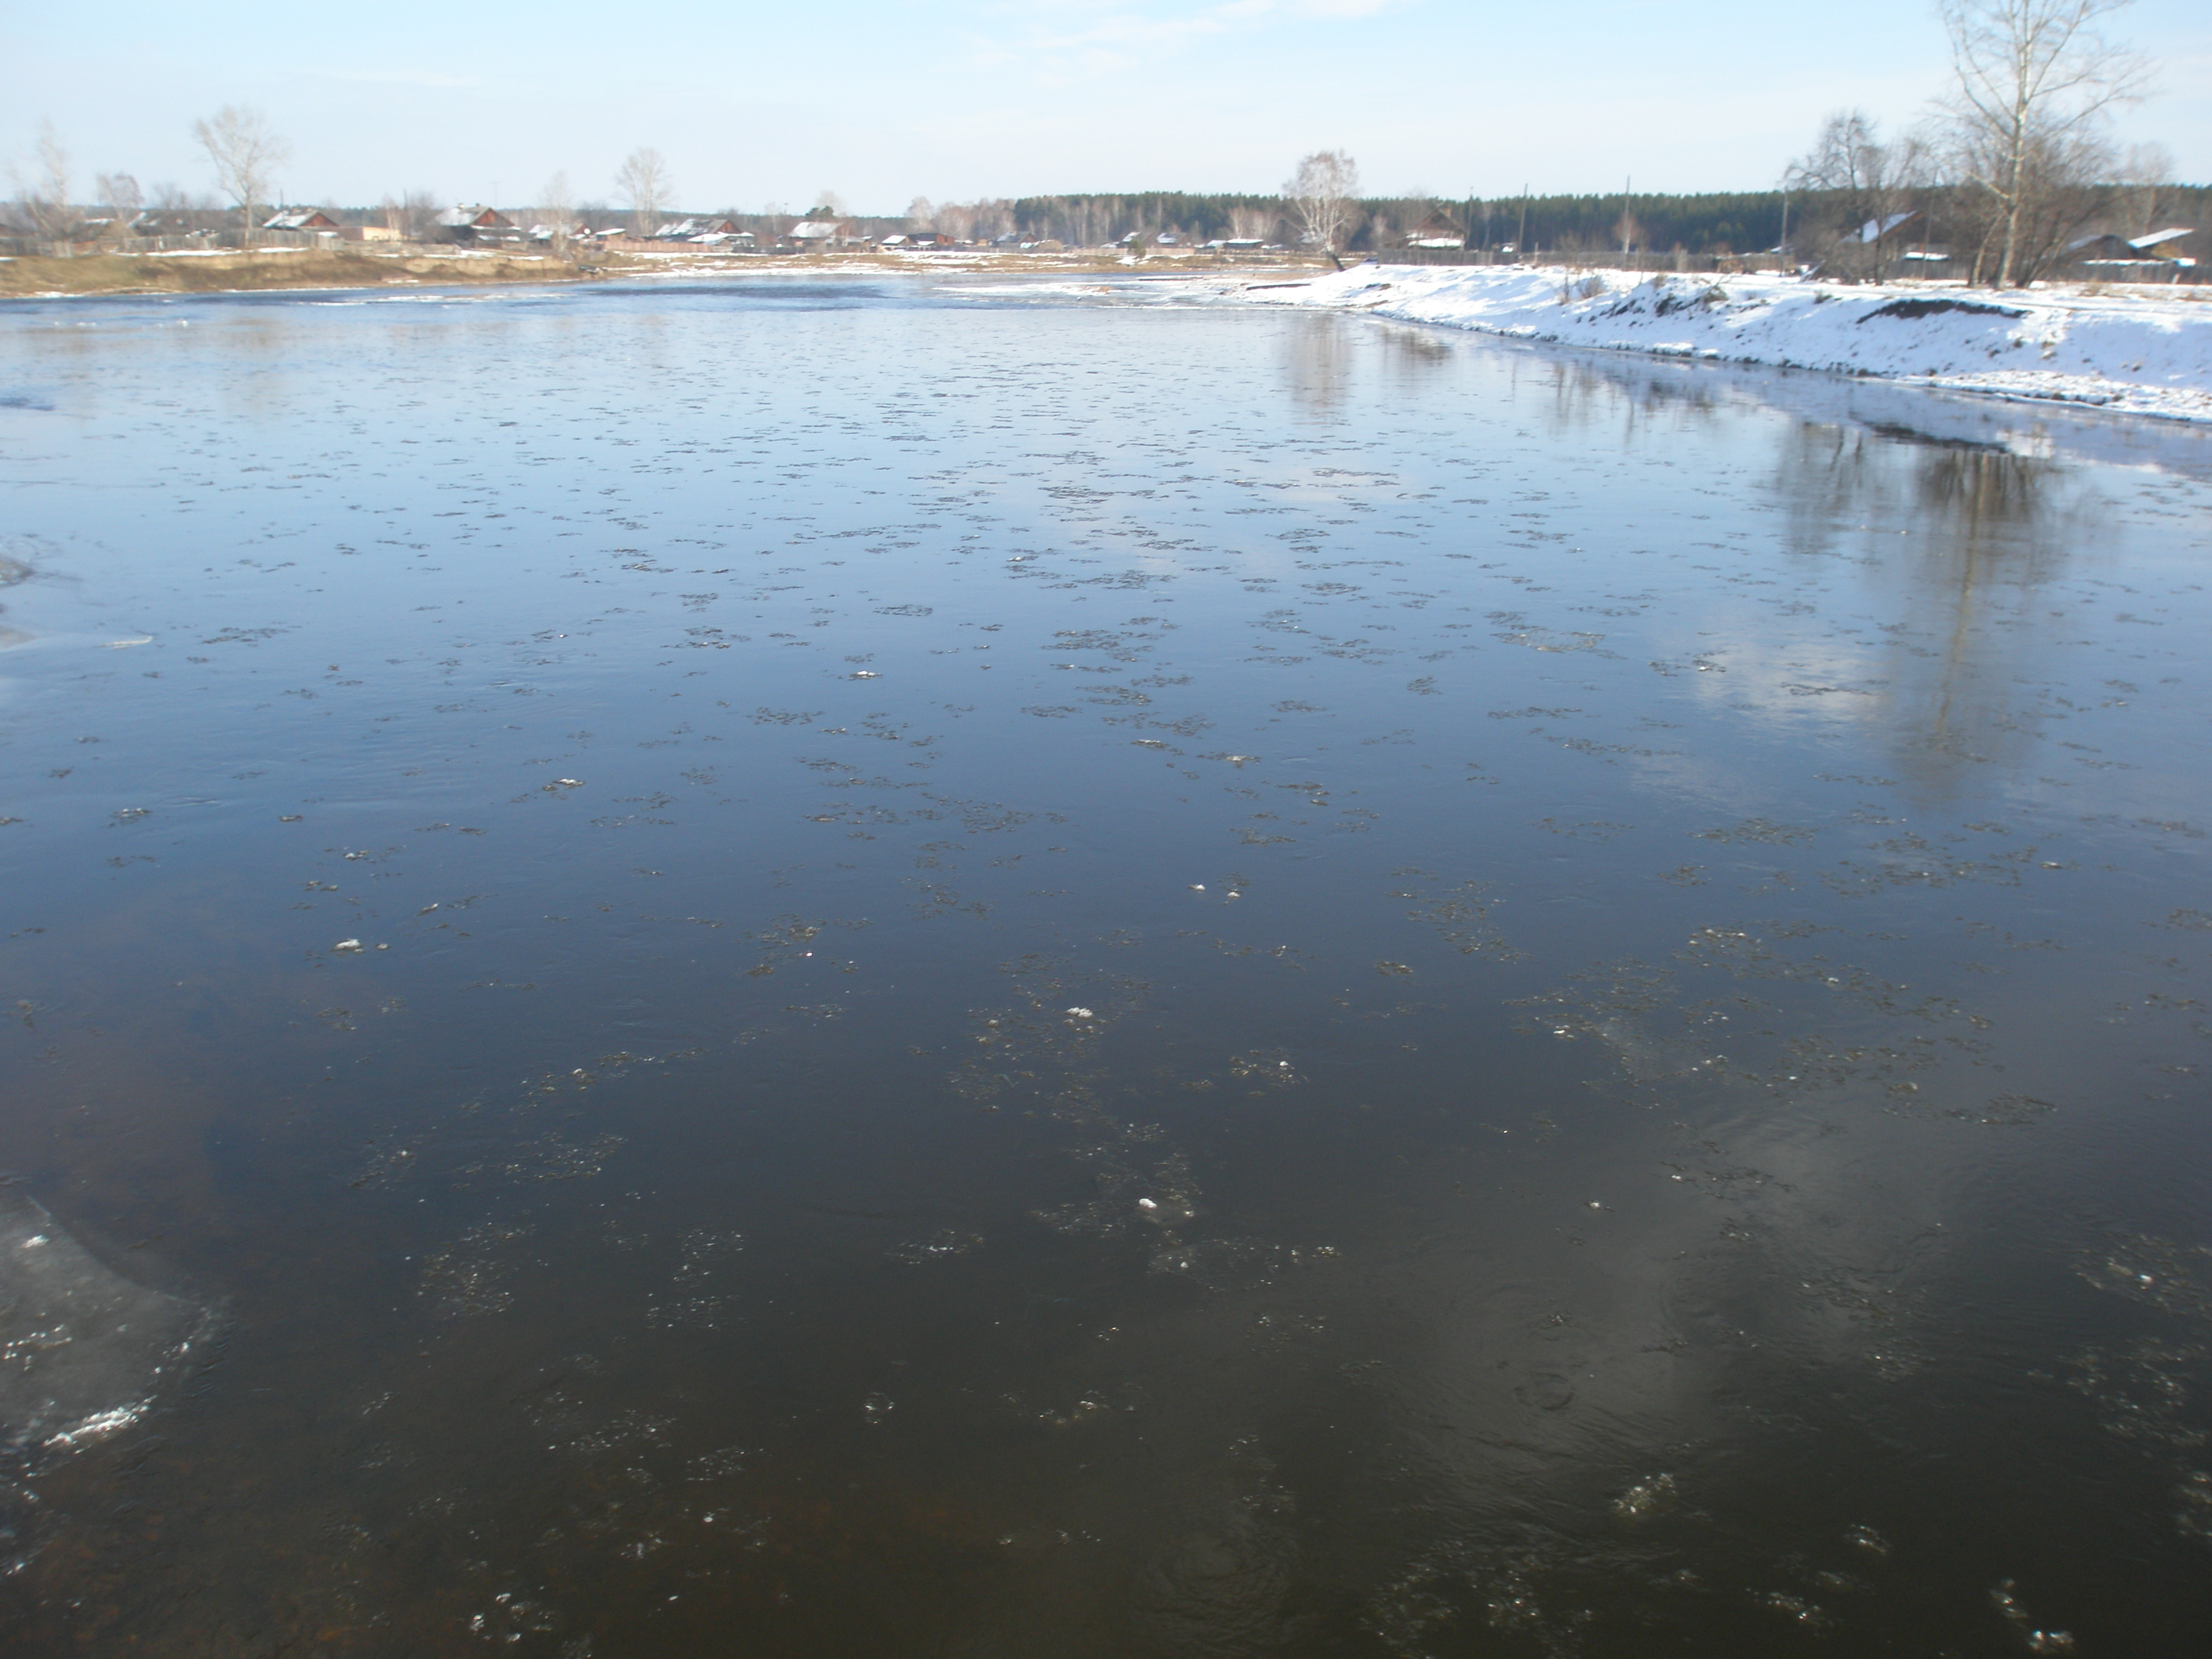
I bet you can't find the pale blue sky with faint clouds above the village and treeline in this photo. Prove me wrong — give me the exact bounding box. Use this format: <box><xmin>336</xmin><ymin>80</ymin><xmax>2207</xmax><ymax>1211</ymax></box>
<box><xmin>0</xmin><ymin>0</ymin><xmax>2212</xmax><ymax>212</ymax></box>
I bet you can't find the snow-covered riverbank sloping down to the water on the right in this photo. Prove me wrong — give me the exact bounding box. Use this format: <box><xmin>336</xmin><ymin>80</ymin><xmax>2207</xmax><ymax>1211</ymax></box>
<box><xmin>1234</xmin><ymin>263</ymin><xmax>2212</xmax><ymax>425</ymax></box>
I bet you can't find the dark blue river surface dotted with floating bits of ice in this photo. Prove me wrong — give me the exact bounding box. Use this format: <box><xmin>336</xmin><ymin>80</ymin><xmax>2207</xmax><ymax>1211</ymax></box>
<box><xmin>0</xmin><ymin>283</ymin><xmax>2212</xmax><ymax>1659</ymax></box>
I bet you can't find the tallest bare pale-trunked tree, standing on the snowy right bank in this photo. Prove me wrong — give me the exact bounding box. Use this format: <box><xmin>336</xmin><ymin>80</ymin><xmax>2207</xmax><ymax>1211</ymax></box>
<box><xmin>1938</xmin><ymin>0</ymin><xmax>2150</xmax><ymax>288</ymax></box>
